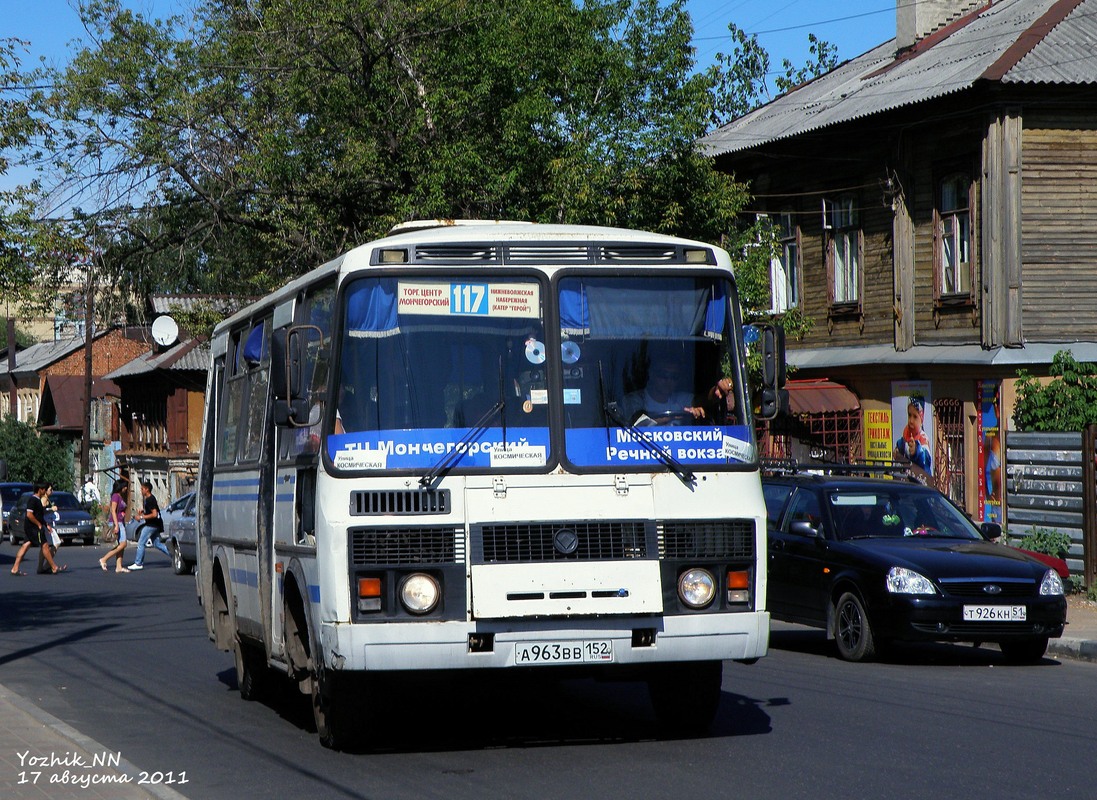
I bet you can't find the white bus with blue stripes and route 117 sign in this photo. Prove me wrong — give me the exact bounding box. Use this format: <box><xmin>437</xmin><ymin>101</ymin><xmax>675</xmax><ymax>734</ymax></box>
<box><xmin>197</xmin><ymin>215</ymin><xmax>783</xmax><ymax>748</ymax></box>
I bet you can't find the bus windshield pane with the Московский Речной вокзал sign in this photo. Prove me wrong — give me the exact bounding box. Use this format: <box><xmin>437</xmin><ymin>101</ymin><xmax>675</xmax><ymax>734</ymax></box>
<box><xmin>558</xmin><ymin>274</ymin><xmax>755</xmax><ymax>469</ymax></box>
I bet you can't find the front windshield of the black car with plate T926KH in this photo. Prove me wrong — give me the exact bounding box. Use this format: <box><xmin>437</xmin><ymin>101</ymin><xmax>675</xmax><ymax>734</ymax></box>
<box><xmin>826</xmin><ymin>484</ymin><xmax>982</xmax><ymax>539</ymax></box>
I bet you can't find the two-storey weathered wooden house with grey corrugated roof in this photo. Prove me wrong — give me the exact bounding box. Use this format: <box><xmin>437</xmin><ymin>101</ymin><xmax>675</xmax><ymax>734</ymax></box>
<box><xmin>701</xmin><ymin>0</ymin><xmax>1097</xmax><ymax>520</ymax></box>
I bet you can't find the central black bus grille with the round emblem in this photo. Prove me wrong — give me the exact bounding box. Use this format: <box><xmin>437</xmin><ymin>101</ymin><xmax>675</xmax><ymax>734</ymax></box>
<box><xmin>472</xmin><ymin>520</ymin><xmax>647</xmax><ymax>564</ymax></box>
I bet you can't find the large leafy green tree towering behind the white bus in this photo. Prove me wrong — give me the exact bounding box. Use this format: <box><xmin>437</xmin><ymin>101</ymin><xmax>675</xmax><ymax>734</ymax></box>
<box><xmin>25</xmin><ymin>0</ymin><xmax>746</xmax><ymax>294</ymax></box>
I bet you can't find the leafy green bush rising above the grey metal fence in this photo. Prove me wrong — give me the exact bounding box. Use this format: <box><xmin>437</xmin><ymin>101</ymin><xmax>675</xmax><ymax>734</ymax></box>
<box><xmin>1014</xmin><ymin>350</ymin><xmax>1097</xmax><ymax>431</ymax></box>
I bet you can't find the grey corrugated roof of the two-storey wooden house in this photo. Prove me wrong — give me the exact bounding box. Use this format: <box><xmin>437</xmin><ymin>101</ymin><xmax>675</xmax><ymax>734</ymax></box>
<box><xmin>699</xmin><ymin>0</ymin><xmax>1097</xmax><ymax>156</ymax></box>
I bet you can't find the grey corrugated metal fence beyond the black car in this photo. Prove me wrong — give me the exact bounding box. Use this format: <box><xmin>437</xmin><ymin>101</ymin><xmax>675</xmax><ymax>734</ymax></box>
<box><xmin>1006</xmin><ymin>429</ymin><xmax>1097</xmax><ymax>585</ymax></box>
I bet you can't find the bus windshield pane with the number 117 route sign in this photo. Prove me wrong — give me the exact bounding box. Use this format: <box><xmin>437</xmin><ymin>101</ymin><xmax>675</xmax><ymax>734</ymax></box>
<box><xmin>328</xmin><ymin>275</ymin><xmax>551</xmax><ymax>470</ymax></box>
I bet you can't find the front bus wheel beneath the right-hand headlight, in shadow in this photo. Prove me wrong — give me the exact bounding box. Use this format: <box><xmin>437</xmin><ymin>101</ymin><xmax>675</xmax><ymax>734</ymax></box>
<box><xmin>647</xmin><ymin>661</ymin><xmax>724</xmax><ymax>736</ymax></box>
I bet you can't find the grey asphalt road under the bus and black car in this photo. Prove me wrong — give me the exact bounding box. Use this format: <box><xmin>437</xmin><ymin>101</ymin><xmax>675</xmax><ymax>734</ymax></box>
<box><xmin>0</xmin><ymin>543</ymin><xmax>1097</xmax><ymax>800</ymax></box>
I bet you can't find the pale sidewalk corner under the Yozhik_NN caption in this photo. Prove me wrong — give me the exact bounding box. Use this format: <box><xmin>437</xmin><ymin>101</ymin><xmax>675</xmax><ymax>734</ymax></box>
<box><xmin>0</xmin><ymin>685</ymin><xmax>186</xmax><ymax>800</ymax></box>
